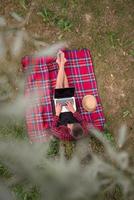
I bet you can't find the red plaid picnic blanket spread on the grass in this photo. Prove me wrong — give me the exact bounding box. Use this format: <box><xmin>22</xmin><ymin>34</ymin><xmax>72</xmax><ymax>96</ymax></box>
<box><xmin>22</xmin><ymin>49</ymin><xmax>105</xmax><ymax>142</ymax></box>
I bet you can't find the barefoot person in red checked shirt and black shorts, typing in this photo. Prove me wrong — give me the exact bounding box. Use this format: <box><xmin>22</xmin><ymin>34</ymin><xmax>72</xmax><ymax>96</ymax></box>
<box><xmin>52</xmin><ymin>51</ymin><xmax>90</xmax><ymax>141</ymax></box>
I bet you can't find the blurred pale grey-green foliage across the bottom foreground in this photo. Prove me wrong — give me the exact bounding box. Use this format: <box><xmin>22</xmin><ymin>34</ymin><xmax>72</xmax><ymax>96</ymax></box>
<box><xmin>0</xmin><ymin>128</ymin><xmax>134</xmax><ymax>200</ymax></box>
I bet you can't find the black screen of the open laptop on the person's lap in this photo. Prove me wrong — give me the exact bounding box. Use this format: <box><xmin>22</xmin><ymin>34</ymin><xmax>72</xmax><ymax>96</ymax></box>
<box><xmin>54</xmin><ymin>88</ymin><xmax>75</xmax><ymax>99</ymax></box>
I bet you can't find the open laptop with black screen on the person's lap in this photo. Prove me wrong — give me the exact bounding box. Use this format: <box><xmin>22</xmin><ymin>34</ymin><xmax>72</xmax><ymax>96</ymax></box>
<box><xmin>54</xmin><ymin>87</ymin><xmax>76</xmax><ymax>113</ymax></box>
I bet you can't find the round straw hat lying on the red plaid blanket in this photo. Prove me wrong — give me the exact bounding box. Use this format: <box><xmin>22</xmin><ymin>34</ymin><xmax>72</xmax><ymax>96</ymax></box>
<box><xmin>82</xmin><ymin>94</ymin><xmax>97</xmax><ymax>112</ymax></box>
